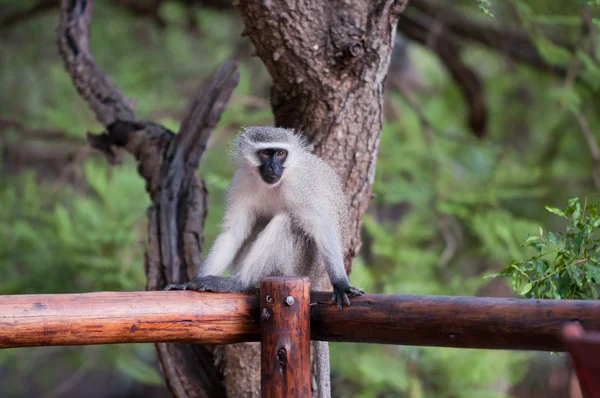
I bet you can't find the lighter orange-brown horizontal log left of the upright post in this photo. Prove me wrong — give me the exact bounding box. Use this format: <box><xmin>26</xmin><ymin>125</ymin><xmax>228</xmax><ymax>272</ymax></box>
<box><xmin>0</xmin><ymin>291</ymin><xmax>260</xmax><ymax>348</ymax></box>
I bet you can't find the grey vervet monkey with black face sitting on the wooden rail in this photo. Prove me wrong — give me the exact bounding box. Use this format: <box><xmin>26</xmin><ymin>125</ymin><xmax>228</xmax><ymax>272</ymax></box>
<box><xmin>166</xmin><ymin>127</ymin><xmax>364</xmax><ymax>397</ymax></box>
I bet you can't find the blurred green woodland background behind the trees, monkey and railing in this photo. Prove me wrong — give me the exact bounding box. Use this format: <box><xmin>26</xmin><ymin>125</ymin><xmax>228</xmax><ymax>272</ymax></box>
<box><xmin>0</xmin><ymin>0</ymin><xmax>600</xmax><ymax>398</ymax></box>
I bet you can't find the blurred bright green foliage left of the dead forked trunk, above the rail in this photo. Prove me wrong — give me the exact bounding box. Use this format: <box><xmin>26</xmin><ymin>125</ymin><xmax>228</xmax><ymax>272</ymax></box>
<box><xmin>0</xmin><ymin>162</ymin><xmax>149</xmax><ymax>294</ymax></box>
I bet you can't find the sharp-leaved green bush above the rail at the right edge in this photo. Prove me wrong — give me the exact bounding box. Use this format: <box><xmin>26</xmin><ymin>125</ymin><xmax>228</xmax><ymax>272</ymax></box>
<box><xmin>492</xmin><ymin>198</ymin><xmax>600</xmax><ymax>299</ymax></box>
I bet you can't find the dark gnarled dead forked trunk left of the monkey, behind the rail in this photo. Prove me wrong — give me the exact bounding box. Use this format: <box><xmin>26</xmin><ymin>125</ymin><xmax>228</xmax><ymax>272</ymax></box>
<box><xmin>58</xmin><ymin>0</ymin><xmax>239</xmax><ymax>397</ymax></box>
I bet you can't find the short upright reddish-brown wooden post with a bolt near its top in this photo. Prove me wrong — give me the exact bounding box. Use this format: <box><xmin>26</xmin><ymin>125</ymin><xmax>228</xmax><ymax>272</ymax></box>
<box><xmin>260</xmin><ymin>277</ymin><xmax>311</xmax><ymax>398</ymax></box>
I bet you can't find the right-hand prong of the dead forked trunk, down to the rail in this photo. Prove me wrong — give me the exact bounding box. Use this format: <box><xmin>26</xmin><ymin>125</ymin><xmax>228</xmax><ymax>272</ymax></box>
<box><xmin>158</xmin><ymin>62</ymin><xmax>240</xmax><ymax>283</ymax></box>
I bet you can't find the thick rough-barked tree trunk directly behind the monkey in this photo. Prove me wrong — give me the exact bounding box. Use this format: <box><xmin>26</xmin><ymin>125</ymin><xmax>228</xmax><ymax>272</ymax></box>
<box><xmin>224</xmin><ymin>0</ymin><xmax>407</xmax><ymax>397</ymax></box>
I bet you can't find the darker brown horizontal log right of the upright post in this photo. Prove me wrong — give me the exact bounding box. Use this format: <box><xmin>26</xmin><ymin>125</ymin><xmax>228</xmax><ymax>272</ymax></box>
<box><xmin>311</xmin><ymin>293</ymin><xmax>600</xmax><ymax>351</ymax></box>
